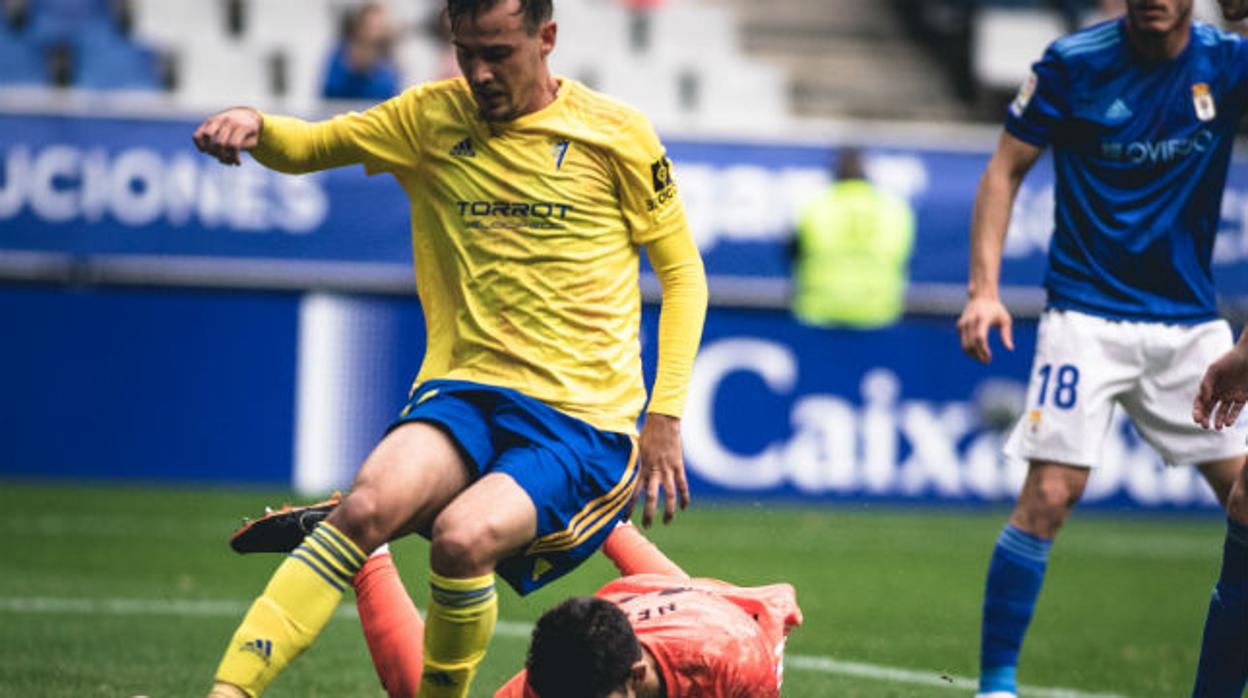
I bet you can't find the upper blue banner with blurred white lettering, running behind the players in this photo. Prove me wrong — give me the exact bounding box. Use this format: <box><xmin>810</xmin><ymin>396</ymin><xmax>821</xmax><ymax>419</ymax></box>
<box><xmin>7</xmin><ymin>109</ymin><xmax>1248</xmax><ymax>295</ymax></box>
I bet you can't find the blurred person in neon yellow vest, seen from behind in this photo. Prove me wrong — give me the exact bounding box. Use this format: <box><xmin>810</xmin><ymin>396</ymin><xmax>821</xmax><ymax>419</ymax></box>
<box><xmin>792</xmin><ymin>147</ymin><xmax>915</xmax><ymax>330</ymax></box>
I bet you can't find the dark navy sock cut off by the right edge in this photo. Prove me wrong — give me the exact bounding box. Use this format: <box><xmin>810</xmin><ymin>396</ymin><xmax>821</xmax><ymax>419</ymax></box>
<box><xmin>1192</xmin><ymin>519</ymin><xmax>1248</xmax><ymax>698</ymax></box>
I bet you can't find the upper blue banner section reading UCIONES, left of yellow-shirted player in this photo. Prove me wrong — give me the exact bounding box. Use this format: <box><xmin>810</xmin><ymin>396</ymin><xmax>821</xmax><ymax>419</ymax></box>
<box><xmin>0</xmin><ymin>111</ymin><xmax>412</xmax><ymax>263</ymax></box>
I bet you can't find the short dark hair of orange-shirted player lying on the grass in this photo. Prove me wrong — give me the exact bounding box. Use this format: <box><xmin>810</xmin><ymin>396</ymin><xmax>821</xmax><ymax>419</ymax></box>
<box><xmin>524</xmin><ymin>597</ymin><xmax>641</xmax><ymax>698</ymax></box>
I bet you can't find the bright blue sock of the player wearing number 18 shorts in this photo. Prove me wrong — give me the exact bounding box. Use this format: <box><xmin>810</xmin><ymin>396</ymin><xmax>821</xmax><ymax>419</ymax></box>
<box><xmin>980</xmin><ymin>523</ymin><xmax>1053</xmax><ymax>693</ymax></box>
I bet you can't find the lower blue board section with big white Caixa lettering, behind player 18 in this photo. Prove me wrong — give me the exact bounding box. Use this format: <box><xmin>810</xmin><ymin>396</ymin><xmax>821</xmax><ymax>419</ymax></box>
<box><xmin>681</xmin><ymin>310</ymin><xmax>1217</xmax><ymax>508</ymax></box>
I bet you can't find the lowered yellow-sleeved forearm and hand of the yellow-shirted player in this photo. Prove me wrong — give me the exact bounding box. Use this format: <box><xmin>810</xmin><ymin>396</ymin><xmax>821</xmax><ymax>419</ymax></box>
<box><xmin>638</xmin><ymin>227</ymin><xmax>706</xmax><ymax>526</ymax></box>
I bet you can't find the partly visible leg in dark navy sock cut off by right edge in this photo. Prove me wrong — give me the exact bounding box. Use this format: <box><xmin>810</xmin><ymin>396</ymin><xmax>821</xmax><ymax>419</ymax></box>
<box><xmin>1192</xmin><ymin>457</ymin><xmax>1248</xmax><ymax>698</ymax></box>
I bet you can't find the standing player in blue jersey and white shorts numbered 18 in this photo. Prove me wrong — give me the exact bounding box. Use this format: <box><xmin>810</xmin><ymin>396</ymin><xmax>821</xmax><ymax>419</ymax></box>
<box><xmin>958</xmin><ymin>0</ymin><xmax>1248</xmax><ymax>698</ymax></box>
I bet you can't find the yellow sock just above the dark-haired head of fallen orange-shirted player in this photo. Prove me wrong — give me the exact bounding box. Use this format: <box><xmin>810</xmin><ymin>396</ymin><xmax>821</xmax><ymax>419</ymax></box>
<box><xmin>419</xmin><ymin>574</ymin><xmax>498</xmax><ymax>698</ymax></box>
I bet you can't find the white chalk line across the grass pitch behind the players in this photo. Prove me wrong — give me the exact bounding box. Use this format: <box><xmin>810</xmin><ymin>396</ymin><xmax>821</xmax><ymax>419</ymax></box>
<box><xmin>0</xmin><ymin>597</ymin><xmax>1126</xmax><ymax>698</ymax></box>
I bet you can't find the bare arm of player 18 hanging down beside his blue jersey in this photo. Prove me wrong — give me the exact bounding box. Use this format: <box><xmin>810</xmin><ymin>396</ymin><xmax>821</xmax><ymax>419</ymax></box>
<box><xmin>957</xmin><ymin>132</ymin><xmax>1042</xmax><ymax>363</ymax></box>
